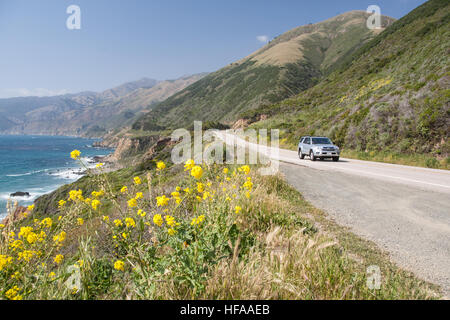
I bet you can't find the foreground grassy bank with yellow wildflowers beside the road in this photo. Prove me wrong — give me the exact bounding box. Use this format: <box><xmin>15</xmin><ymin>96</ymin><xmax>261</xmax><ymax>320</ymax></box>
<box><xmin>0</xmin><ymin>150</ymin><xmax>439</xmax><ymax>300</ymax></box>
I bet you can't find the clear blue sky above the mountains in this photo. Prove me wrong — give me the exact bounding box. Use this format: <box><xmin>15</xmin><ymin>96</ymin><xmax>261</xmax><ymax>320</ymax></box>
<box><xmin>0</xmin><ymin>0</ymin><xmax>425</xmax><ymax>98</ymax></box>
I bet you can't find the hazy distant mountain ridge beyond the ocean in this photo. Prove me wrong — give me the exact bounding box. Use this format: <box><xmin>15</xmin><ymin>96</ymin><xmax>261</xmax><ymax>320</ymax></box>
<box><xmin>0</xmin><ymin>74</ymin><xmax>205</xmax><ymax>137</ymax></box>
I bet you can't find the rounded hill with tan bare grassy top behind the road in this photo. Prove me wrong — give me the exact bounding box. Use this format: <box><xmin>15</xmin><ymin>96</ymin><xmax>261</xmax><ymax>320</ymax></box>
<box><xmin>133</xmin><ymin>11</ymin><xmax>393</xmax><ymax>130</ymax></box>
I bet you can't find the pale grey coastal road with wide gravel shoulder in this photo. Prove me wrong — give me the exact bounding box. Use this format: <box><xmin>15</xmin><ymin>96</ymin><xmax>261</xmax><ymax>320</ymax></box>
<box><xmin>217</xmin><ymin>132</ymin><xmax>450</xmax><ymax>297</ymax></box>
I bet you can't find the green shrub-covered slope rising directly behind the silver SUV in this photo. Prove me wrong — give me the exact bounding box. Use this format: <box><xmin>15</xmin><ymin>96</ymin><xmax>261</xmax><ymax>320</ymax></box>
<box><xmin>246</xmin><ymin>0</ymin><xmax>450</xmax><ymax>167</ymax></box>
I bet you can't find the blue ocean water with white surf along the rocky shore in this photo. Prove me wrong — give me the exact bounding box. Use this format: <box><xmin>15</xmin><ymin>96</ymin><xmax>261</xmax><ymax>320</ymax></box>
<box><xmin>0</xmin><ymin>135</ymin><xmax>112</xmax><ymax>220</ymax></box>
